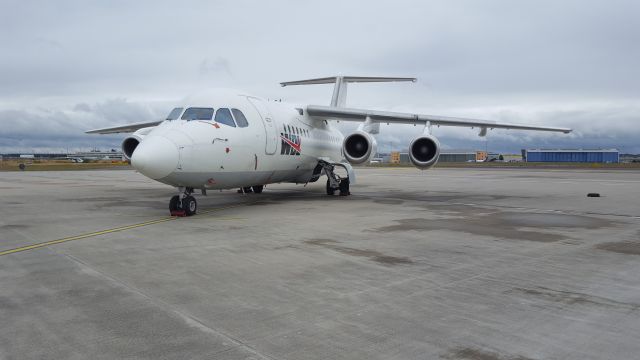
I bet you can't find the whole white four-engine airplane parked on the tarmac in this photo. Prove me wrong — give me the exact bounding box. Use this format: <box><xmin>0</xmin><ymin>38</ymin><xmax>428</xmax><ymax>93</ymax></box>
<box><xmin>87</xmin><ymin>76</ymin><xmax>571</xmax><ymax>216</ymax></box>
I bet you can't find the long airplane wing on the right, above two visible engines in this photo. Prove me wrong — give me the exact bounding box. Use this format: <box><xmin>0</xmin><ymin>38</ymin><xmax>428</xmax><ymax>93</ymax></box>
<box><xmin>307</xmin><ymin>105</ymin><xmax>572</xmax><ymax>134</ymax></box>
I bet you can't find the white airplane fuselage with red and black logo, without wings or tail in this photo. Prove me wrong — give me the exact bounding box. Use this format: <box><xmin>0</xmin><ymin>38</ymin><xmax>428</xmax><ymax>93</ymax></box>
<box><xmin>131</xmin><ymin>95</ymin><xmax>344</xmax><ymax>189</ymax></box>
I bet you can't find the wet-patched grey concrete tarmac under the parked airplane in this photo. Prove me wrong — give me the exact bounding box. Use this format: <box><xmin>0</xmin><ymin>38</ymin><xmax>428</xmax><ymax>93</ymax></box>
<box><xmin>0</xmin><ymin>169</ymin><xmax>640</xmax><ymax>360</ymax></box>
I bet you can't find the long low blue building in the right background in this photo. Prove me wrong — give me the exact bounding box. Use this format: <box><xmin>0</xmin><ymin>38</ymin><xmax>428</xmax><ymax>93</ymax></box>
<box><xmin>522</xmin><ymin>149</ymin><xmax>620</xmax><ymax>163</ymax></box>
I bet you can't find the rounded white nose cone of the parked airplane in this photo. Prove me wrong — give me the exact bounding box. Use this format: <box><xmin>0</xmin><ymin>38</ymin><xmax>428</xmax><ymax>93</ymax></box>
<box><xmin>131</xmin><ymin>136</ymin><xmax>178</xmax><ymax>180</ymax></box>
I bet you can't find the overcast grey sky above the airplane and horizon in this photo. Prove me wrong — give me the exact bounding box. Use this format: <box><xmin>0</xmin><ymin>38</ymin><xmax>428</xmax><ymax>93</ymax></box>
<box><xmin>0</xmin><ymin>0</ymin><xmax>640</xmax><ymax>153</ymax></box>
